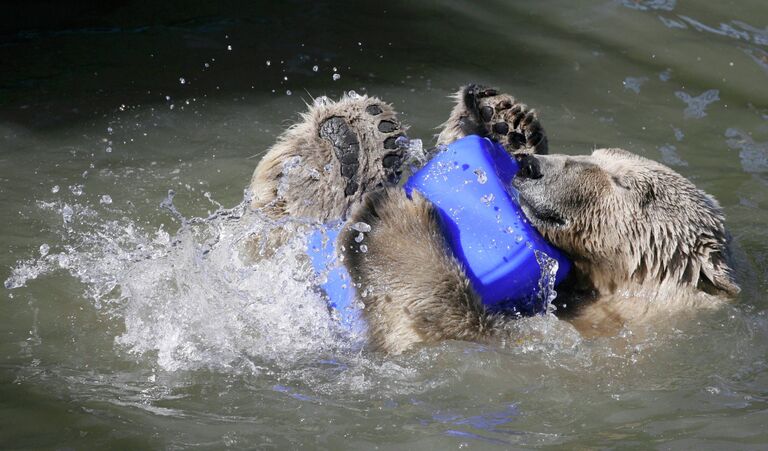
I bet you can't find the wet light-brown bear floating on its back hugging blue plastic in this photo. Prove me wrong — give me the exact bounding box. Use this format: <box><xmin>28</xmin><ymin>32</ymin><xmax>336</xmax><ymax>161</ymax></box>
<box><xmin>252</xmin><ymin>84</ymin><xmax>739</xmax><ymax>354</ymax></box>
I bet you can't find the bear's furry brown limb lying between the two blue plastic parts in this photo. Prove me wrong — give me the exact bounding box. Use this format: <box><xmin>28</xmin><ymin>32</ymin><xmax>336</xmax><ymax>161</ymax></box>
<box><xmin>338</xmin><ymin>187</ymin><xmax>498</xmax><ymax>354</ymax></box>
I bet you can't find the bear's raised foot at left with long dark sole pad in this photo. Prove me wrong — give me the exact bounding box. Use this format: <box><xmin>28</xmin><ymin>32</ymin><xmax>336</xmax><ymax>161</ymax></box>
<box><xmin>250</xmin><ymin>95</ymin><xmax>406</xmax><ymax>222</ymax></box>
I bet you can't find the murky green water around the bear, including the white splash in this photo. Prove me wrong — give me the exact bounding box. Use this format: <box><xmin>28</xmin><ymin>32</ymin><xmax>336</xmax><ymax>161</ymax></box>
<box><xmin>0</xmin><ymin>0</ymin><xmax>768</xmax><ymax>449</ymax></box>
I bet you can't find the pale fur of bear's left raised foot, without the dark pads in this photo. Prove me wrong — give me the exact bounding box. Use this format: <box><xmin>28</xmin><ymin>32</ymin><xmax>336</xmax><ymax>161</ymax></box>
<box><xmin>250</xmin><ymin>95</ymin><xmax>406</xmax><ymax>222</ymax></box>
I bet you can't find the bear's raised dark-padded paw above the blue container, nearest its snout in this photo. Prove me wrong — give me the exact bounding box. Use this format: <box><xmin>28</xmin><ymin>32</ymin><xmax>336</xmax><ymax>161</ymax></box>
<box><xmin>437</xmin><ymin>84</ymin><xmax>548</xmax><ymax>154</ymax></box>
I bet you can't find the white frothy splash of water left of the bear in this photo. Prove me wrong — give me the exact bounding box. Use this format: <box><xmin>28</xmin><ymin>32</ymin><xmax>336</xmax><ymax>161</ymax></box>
<box><xmin>5</xmin><ymin>191</ymin><xmax>357</xmax><ymax>373</ymax></box>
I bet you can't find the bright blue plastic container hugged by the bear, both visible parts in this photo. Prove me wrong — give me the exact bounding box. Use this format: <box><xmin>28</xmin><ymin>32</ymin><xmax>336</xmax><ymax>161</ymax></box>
<box><xmin>308</xmin><ymin>136</ymin><xmax>570</xmax><ymax>324</ymax></box>
